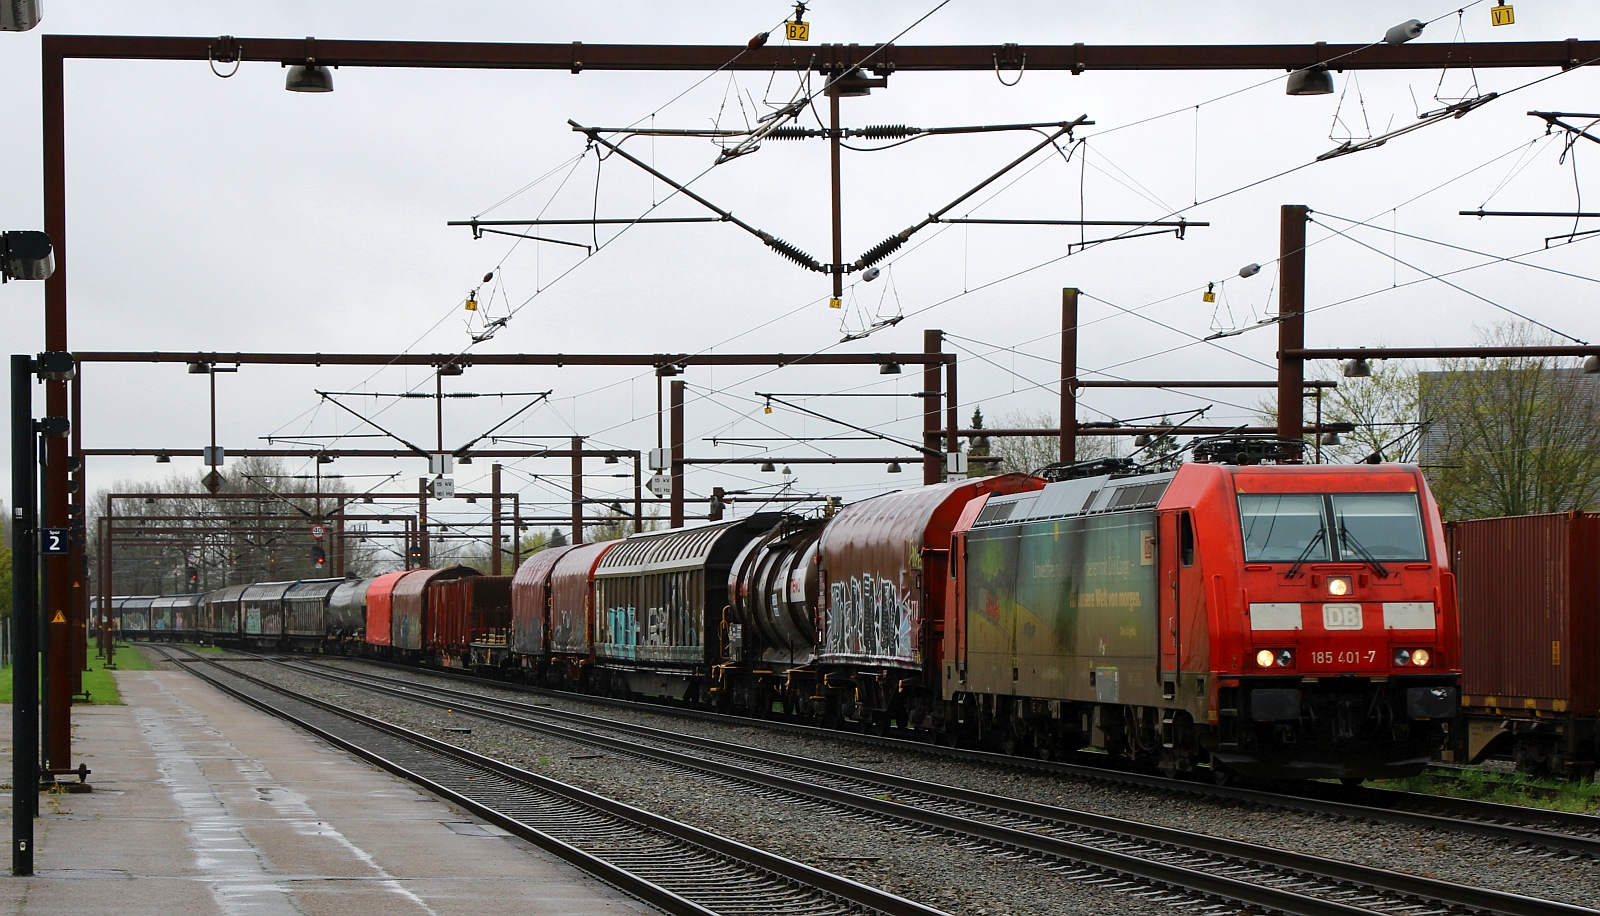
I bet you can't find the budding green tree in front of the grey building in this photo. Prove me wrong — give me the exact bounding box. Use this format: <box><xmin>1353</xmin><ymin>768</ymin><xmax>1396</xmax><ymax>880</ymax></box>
<box><xmin>1419</xmin><ymin>325</ymin><xmax>1600</xmax><ymax>519</ymax></box>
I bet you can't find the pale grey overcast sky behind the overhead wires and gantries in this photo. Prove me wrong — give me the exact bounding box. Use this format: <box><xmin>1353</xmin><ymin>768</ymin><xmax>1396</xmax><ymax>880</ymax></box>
<box><xmin>0</xmin><ymin>0</ymin><xmax>1600</xmax><ymax>538</ymax></box>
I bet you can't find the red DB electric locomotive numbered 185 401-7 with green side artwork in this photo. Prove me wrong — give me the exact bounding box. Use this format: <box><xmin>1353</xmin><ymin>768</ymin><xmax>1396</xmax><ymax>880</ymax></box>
<box><xmin>942</xmin><ymin>448</ymin><xmax>1459</xmax><ymax>780</ymax></box>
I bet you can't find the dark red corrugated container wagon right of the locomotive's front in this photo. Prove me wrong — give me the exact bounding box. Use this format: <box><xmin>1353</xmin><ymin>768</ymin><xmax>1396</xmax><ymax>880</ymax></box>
<box><xmin>1446</xmin><ymin>512</ymin><xmax>1600</xmax><ymax>775</ymax></box>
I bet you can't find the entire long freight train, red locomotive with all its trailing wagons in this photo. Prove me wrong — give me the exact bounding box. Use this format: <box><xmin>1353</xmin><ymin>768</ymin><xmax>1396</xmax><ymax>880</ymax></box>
<box><xmin>112</xmin><ymin>450</ymin><xmax>1461</xmax><ymax>781</ymax></box>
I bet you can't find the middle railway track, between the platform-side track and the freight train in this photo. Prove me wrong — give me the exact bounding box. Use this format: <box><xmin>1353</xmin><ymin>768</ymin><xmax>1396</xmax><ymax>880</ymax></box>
<box><xmin>256</xmin><ymin>661</ymin><xmax>1590</xmax><ymax>914</ymax></box>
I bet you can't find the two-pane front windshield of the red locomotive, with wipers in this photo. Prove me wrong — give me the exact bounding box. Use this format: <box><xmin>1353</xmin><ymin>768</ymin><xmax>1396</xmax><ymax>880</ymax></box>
<box><xmin>1238</xmin><ymin>493</ymin><xmax>1427</xmax><ymax>564</ymax></box>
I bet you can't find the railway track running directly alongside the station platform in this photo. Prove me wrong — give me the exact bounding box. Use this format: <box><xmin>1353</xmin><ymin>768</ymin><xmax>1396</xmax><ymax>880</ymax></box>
<box><xmin>148</xmin><ymin>647</ymin><xmax>939</xmax><ymax>916</ymax></box>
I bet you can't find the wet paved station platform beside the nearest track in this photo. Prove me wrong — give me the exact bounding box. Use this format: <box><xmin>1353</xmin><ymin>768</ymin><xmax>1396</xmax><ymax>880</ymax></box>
<box><xmin>0</xmin><ymin>671</ymin><xmax>656</xmax><ymax>916</ymax></box>
